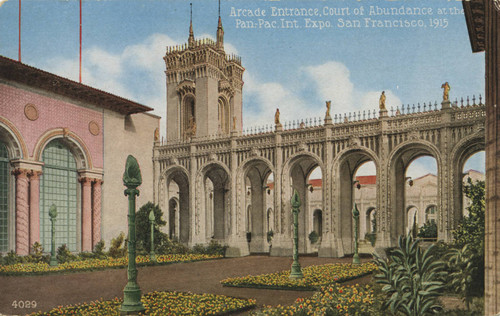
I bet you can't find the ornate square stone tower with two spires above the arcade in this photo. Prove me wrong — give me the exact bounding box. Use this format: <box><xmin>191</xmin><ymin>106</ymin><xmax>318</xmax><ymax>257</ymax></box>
<box><xmin>163</xmin><ymin>8</ymin><xmax>245</xmax><ymax>141</ymax></box>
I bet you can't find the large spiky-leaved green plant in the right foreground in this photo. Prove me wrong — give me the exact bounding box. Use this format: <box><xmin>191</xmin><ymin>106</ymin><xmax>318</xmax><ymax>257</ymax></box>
<box><xmin>375</xmin><ymin>235</ymin><xmax>446</xmax><ymax>316</ymax></box>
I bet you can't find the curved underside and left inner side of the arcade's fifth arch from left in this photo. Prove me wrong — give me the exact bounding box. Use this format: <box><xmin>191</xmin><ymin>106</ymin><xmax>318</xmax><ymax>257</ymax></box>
<box><xmin>332</xmin><ymin>146</ymin><xmax>380</xmax><ymax>254</ymax></box>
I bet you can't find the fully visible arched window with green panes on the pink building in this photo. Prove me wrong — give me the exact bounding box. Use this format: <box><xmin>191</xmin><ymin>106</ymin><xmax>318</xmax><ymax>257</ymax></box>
<box><xmin>40</xmin><ymin>139</ymin><xmax>79</xmax><ymax>251</ymax></box>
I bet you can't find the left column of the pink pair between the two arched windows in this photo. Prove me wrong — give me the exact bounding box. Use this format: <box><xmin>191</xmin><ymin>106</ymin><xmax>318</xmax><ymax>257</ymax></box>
<box><xmin>12</xmin><ymin>168</ymin><xmax>30</xmax><ymax>256</ymax></box>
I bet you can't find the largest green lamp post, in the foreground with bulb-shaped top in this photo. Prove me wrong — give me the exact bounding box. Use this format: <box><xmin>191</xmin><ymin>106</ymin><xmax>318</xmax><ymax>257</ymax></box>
<box><xmin>120</xmin><ymin>155</ymin><xmax>145</xmax><ymax>315</ymax></box>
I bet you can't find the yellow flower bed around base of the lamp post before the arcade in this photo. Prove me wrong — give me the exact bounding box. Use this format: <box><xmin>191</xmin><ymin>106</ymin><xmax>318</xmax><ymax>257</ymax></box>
<box><xmin>221</xmin><ymin>262</ymin><xmax>377</xmax><ymax>291</ymax></box>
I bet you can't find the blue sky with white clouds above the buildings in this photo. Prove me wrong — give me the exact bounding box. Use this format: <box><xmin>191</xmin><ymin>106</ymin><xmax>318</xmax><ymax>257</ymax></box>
<box><xmin>0</xmin><ymin>0</ymin><xmax>484</xmax><ymax>177</ymax></box>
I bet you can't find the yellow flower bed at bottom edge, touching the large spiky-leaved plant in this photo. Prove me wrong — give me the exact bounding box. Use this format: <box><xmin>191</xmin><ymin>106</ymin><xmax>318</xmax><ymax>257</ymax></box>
<box><xmin>252</xmin><ymin>284</ymin><xmax>376</xmax><ymax>316</ymax></box>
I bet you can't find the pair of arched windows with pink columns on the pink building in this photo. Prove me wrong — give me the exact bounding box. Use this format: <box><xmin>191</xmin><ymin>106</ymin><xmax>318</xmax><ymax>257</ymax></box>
<box><xmin>0</xmin><ymin>117</ymin><xmax>100</xmax><ymax>254</ymax></box>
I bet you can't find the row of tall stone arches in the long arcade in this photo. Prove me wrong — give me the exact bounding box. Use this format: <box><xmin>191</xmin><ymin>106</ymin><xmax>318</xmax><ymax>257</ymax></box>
<box><xmin>158</xmin><ymin>135</ymin><xmax>484</xmax><ymax>253</ymax></box>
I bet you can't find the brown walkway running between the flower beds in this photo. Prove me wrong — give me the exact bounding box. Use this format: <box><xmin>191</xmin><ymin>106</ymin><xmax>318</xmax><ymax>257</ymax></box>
<box><xmin>0</xmin><ymin>256</ymin><xmax>370</xmax><ymax>315</ymax></box>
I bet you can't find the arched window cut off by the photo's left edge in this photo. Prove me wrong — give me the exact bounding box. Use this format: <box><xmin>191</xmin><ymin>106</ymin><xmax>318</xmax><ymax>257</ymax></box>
<box><xmin>0</xmin><ymin>142</ymin><xmax>9</xmax><ymax>252</ymax></box>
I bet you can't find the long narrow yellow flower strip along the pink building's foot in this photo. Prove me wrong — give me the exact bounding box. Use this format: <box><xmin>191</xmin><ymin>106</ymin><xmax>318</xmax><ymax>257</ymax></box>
<box><xmin>0</xmin><ymin>254</ymin><xmax>222</xmax><ymax>275</ymax></box>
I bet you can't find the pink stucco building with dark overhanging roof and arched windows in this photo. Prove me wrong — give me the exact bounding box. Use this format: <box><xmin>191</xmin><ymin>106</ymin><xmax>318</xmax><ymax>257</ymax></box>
<box><xmin>0</xmin><ymin>56</ymin><xmax>159</xmax><ymax>255</ymax></box>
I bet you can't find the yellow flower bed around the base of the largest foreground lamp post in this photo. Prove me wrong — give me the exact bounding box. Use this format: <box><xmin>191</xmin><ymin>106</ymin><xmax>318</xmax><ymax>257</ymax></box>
<box><xmin>31</xmin><ymin>291</ymin><xmax>255</xmax><ymax>316</ymax></box>
